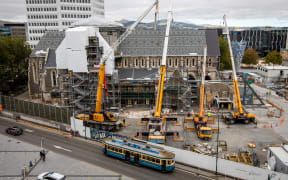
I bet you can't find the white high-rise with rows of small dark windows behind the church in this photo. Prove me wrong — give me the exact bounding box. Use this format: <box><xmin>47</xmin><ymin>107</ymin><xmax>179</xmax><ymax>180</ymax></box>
<box><xmin>26</xmin><ymin>0</ymin><xmax>104</xmax><ymax>48</ymax></box>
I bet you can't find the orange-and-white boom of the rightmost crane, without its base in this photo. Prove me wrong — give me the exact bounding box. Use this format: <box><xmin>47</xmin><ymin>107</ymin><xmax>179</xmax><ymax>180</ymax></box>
<box><xmin>223</xmin><ymin>15</ymin><xmax>244</xmax><ymax>114</ymax></box>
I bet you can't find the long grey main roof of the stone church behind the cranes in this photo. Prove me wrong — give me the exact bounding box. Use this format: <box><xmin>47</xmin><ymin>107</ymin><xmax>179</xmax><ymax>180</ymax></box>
<box><xmin>119</xmin><ymin>29</ymin><xmax>220</xmax><ymax>56</ymax></box>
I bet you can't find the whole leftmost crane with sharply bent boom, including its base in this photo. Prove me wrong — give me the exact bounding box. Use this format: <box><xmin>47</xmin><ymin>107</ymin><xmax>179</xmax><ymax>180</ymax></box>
<box><xmin>76</xmin><ymin>0</ymin><xmax>159</xmax><ymax>130</ymax></box>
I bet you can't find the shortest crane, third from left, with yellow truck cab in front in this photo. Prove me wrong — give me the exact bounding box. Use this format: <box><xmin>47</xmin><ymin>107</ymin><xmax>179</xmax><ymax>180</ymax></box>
<box><xmin>193</xmin><ymin>45</ymin><xmax>212</xmax><ymax>139</ymax></box>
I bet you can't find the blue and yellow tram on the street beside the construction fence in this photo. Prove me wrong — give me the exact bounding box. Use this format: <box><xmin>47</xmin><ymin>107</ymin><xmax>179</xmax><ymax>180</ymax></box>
<box><xmin>103</xmin><ymin>137</ymin><xmax>175</xmax><ymax>172</ymax></box>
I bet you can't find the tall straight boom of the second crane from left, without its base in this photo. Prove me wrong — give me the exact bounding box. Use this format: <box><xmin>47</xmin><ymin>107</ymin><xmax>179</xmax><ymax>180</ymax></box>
<box><xmin>154</xmin><ymin>0</ymin><xmax>173</xmax><ymax>117</ymax></box>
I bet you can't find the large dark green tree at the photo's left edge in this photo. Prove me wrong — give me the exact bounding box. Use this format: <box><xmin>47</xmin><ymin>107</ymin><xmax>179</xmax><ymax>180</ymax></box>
<box><xmin>0</xmin><ymin>36</ymin><xmax>31</xmax><ymax>93</ymax></box>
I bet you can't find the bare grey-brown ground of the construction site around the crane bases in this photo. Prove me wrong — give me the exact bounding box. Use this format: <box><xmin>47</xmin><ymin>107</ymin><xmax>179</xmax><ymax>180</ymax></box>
<box><xmin>119</xmin><ymin>107</ymin><xmax>286</xmax><ymax>167</ymax></box>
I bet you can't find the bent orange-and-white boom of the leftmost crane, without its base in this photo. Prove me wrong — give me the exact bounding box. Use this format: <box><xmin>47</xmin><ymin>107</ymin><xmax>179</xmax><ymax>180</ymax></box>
<box><xmin>95</xmin><ymin>0</ymin><xmax>159</xmax><ymax>113</ymax></box>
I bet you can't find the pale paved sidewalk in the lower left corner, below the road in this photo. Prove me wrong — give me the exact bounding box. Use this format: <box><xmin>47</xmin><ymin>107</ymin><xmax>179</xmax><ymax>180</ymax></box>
<box><xmin>0</xmin><ymin>134</ymin><xmax>131</xmax><ymax>180</ymax></box>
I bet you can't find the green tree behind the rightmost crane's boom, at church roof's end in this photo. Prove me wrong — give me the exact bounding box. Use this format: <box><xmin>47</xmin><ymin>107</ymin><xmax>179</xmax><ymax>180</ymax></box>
<box><xmin>219</xmin><ymin>37</ymin><xmax>232</xmax><ymax>71</ymax></box>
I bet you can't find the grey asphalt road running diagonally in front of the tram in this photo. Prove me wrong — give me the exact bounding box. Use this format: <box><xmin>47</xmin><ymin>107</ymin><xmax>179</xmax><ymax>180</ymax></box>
<box><xmin>0</xmin><ymin>116</ymin><xmax>202</xmax><ymax>180</ymax></box>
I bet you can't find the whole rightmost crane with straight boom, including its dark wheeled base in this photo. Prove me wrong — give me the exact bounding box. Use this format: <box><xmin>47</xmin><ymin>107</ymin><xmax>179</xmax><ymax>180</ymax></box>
<box><xmin>223</xmin><ymin>15</ymin><xmax>255</xmax><ymax>124</ymax></box>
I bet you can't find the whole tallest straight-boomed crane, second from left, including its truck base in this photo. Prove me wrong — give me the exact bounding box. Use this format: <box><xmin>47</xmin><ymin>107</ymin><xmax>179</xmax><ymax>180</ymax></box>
<box><xmin>148</xmin><ymin>0</ymin><xmax>173</xmax><ymax>144</ymax></box>
